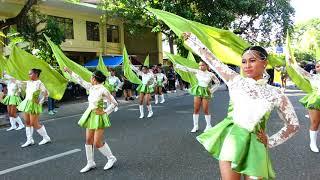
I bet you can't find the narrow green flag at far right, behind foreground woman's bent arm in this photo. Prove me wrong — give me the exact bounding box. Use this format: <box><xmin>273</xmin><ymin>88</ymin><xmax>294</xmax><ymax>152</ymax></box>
<box><xmin>286</xmin><ymin>32</ymin><xmax>312</xmax><ymax>93</ymax></box>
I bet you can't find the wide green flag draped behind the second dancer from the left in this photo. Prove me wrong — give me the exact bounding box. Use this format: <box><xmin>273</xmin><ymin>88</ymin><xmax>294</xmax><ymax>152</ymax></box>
<box><xmin>5</xmin><ymin>46</ymin><xmax>68</xmax><ymax>100</ymax></box>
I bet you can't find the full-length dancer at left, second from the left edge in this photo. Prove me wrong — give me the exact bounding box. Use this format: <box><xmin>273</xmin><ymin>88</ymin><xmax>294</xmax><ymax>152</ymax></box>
<box><xmin>18</xmin><ymin>69</ymin><xmax>51</xmax><ymax>147</ymax></box>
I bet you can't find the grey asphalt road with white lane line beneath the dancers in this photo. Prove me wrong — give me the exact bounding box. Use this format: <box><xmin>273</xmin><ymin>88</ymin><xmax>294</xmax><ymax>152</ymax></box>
<box><xmin>0</xmin><ymin>90</ymin><xmax>320</xmax><ymax>180</ymax></box>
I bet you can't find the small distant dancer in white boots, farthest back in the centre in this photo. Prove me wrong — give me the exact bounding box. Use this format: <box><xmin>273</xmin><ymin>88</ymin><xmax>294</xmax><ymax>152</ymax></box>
<box><xmin>154</xmin><ymin>68</ymin><xmax>168</xmax><ymax>104</ymax></box>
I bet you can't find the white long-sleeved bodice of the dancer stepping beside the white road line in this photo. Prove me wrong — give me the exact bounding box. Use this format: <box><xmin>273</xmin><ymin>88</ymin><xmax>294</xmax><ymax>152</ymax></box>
<box><xmin>71</xmin><ymin>72</ymin><xmax>118</xmax><ymax>114</ymax></box>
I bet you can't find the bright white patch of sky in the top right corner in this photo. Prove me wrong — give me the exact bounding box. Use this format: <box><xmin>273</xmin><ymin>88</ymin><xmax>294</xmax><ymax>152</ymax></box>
<box><xmin>291</xmin><ymin>0</ymin><xmax>320</xmax><ymax>23</ymax></box>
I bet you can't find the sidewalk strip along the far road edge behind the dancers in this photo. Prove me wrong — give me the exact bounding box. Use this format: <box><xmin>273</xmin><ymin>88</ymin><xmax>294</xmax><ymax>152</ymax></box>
<box><xmin>0</xmin><ymin>90</ymin><xmax>189</xmax><ymax>127</ymax></box>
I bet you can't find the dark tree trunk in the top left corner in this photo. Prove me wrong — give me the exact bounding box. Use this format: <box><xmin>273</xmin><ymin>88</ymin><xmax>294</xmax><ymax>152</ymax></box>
<box><xmin>0</xmin><ymin>0</ymin><xmax>37</xmax><ymax>29</ymax></box>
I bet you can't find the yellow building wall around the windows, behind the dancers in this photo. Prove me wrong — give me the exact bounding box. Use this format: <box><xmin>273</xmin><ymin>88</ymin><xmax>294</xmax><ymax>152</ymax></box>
<box><xmin>0</xmin><ymin>0</ymin><xmax>163</xmax><ymax>64</ymax></box>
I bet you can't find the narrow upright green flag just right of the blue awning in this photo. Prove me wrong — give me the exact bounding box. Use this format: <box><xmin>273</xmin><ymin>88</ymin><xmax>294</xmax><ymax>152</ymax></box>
<box><xmin>122</xmin><ymin>47</ymin><xmax>142</xmax><ymax>84</ymax></box>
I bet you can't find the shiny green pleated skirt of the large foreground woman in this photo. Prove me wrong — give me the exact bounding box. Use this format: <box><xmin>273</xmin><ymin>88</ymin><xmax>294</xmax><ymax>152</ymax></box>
<box><xmin>197</xmin><ymin>118</ymin><xmax>275</xmax><ymax>179</ymax></box>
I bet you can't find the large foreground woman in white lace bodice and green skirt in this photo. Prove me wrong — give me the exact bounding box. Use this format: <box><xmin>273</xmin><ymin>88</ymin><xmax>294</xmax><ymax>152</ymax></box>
<box><xmin>183</xmin><ymin>33</ymin><xmax>299</xmax><ymax>180</ymax></box>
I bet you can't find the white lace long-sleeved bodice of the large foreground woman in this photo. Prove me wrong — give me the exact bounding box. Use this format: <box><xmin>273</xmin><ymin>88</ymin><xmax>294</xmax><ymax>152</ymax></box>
<box><xmin>185</xmin><ymin>34</ymin><xmax>299</xmax><ymax>147</ymax></box>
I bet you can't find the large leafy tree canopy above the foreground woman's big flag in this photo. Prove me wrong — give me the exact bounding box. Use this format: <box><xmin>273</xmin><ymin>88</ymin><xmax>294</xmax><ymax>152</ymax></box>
<box><xmin>90</xmin><ymin>0</ymin><xmax>294</xmax><ymax>51</ymax></box>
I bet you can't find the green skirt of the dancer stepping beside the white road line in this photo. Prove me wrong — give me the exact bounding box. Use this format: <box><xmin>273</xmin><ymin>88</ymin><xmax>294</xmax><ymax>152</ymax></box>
<box><xmin>78</xmin><ymin>109</ymin><xmax>111</xmax><ymax>129</ymax></box>
